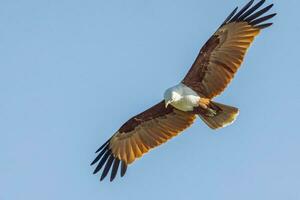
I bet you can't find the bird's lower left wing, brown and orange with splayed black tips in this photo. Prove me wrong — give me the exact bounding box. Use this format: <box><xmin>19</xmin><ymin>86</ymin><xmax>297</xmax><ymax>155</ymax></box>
<box><xmin>92</xmin><ymin>101</ymin><xmax>196</xmax><ymax>181</ymax></box>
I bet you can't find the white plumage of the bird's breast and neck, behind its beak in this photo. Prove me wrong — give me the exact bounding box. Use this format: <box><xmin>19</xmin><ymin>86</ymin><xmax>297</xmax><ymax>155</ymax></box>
<box><xmin>171</xmin><ymin>83</ymin><xmax>200</xmax><ymax>111</ymax></box>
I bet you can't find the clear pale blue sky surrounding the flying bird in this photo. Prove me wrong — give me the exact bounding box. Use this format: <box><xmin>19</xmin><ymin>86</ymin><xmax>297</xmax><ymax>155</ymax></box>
<box><xmin>0</xmin><ymin>0</ymin><xmax>300</xmax><ymax>200</ymax></box>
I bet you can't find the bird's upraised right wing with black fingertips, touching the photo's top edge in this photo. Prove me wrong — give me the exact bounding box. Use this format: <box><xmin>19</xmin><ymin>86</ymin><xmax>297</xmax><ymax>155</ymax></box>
<box><xmin>182</xmin><ymin>0</ymin><xmax>276</xmax><ymax>98</ymax></box>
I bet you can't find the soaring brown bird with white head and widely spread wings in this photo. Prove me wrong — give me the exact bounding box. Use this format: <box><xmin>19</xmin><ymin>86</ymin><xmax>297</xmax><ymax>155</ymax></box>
<box><xmin>91</xmin><ymin>0</ymin><xmax>276</xmax><ymax>181</ymax></box>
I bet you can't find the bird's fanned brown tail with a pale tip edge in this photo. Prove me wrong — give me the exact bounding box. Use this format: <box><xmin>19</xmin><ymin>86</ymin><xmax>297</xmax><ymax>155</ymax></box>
<box><xmin>199</xmin><ymin>101</ymin><xmax>239</xmax><ymax>129</ymax></box>
